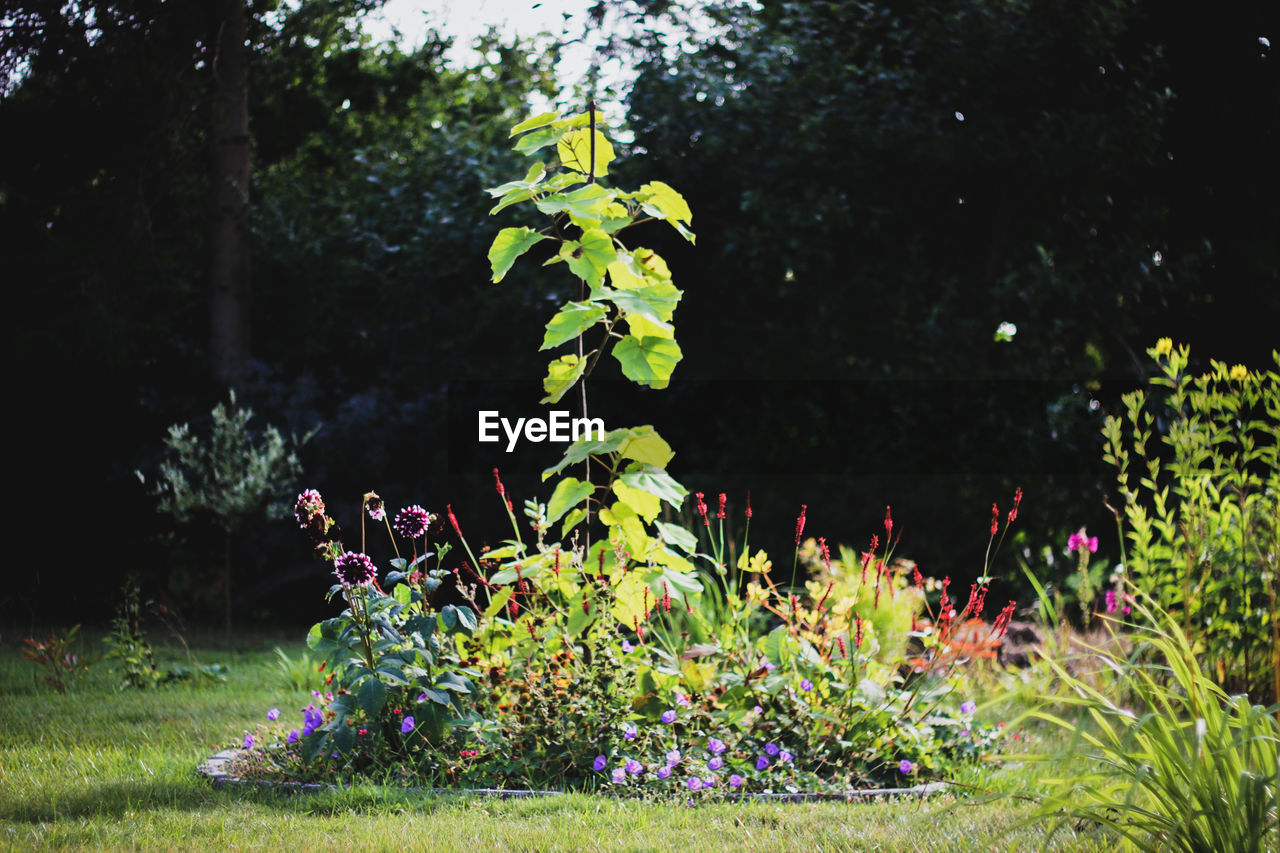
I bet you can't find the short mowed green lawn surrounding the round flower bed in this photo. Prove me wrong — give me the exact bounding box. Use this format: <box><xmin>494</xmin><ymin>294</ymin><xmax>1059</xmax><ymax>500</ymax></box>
<box><xmin>0</xmin><ymin>630</ymin><xmax>1110</xmax><ymax>853</ymax></box>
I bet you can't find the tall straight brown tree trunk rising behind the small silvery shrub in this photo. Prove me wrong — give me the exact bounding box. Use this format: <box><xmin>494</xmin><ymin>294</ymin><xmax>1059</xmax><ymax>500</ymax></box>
<box><xmin>209</xmin><ymin>0</ymin><xmax>250</xmax><ymax>384</ymax></box>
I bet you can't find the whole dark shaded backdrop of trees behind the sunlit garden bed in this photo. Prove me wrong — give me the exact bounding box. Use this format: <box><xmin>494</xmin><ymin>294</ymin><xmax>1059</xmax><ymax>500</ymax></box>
<box><xmin>0</xmin><ymin>0</ymin><xmax>1280</xmax><ymax>625</ymax></box>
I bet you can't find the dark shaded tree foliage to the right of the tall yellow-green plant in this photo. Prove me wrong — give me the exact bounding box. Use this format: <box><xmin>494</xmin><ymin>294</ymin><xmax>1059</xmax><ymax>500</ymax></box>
<box><xmin>614</xmin><ymin>0</ymin><xmax>1280</xmax><ymax>584</ymax></box>
